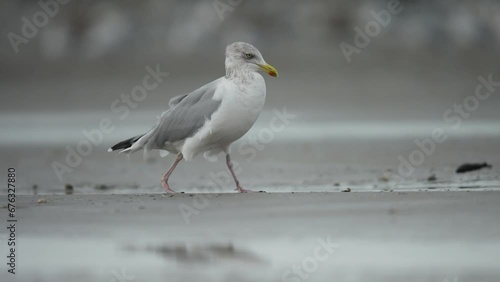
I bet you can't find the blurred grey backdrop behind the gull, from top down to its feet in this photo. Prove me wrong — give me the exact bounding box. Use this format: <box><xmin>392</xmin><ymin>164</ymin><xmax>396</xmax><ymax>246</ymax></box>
<box><xmin>0</xmin><ymin>0</ymin><xmax>500</xmax><ymax>193</ymax></box>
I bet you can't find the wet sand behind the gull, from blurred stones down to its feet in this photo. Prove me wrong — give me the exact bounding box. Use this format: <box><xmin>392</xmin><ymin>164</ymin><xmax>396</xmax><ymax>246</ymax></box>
<box><xmin>0</xmin><ymin>55</ymin><xmax>500</xmax><ymax>195</ymax></box>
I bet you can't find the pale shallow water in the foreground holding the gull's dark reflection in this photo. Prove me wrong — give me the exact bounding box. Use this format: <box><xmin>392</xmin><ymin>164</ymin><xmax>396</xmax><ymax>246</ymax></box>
<box><xmin>8</xmin><ymin>237</ymin><xmax>500</xmax><ymax>282</ymax></box>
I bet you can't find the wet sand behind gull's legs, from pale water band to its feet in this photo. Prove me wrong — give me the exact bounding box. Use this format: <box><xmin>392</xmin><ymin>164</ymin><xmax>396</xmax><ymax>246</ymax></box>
<box><xmin>0</xmin><ymin>111</ymin><xmax>500</xmax><ymax>195</ymax></box>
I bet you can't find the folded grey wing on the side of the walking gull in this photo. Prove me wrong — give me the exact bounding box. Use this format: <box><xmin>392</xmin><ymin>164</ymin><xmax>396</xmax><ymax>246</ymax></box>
<box><xmin>149</xmin><ymin>77</ymin><xmax>221</xmax><ymax>148</ymax></box>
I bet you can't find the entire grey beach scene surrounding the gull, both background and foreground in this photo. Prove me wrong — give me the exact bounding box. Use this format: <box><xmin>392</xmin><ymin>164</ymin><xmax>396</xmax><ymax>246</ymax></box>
<box><xmin>0</xmin><ymin>0</ymin><xmax>500</xmax><ymax>282</ymax></box>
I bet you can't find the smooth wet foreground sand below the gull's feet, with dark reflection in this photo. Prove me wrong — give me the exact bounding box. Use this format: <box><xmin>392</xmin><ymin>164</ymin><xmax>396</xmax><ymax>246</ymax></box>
<box><xmin>0</xmin><ymin>191</ymin><xmax>500</xmax><ymax>282</ymax></box>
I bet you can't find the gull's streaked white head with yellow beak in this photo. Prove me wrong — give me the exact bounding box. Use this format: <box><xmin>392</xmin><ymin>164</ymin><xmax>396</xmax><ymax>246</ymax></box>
<box><xmin>226</xmin><ymin>42</ymin><xmax>278</xmax><ymax>77</ymax></box>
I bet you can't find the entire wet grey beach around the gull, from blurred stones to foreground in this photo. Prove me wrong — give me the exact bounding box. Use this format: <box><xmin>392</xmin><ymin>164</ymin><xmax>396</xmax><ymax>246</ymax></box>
<box><xmin>0</xmin><ymin>54</ymin><xmax>500</xmax><ymax>282</ymax></box>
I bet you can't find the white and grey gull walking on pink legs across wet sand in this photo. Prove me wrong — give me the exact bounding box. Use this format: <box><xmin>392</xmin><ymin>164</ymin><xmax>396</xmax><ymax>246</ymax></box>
<box><xmin>108</xmin><ymin>42</ymin><xmax>278</xmax><ymax>193</ymax></box>
